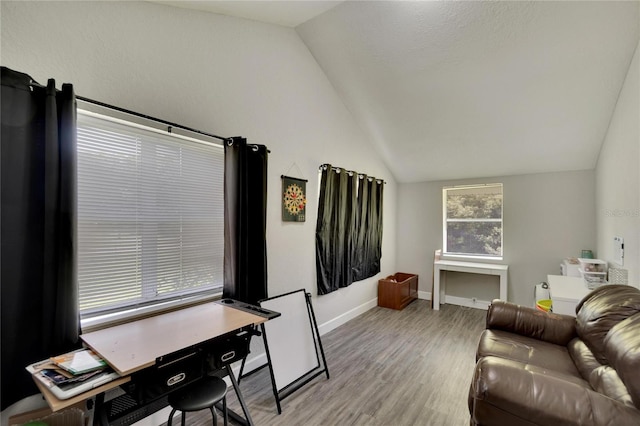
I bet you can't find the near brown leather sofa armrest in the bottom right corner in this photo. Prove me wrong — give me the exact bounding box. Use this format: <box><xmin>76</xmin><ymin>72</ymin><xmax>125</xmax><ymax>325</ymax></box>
<box><xmin>469</xmin><ymin>356</ymin><xmax>640</xmax><ymax>426</ymax></box>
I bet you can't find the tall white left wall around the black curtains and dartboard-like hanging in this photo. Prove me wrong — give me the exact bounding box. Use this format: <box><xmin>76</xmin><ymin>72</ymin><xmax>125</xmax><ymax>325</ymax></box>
<box><xmin>0</xmin><ymin>1</ymin><xmax>397</xmax><ymax>422</ymax></box>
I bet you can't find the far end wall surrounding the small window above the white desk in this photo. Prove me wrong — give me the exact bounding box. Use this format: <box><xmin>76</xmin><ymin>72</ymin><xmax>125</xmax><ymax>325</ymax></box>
<box><xmin>398</xmin><ymin>170</ymin><xmax>596</xmax><ymax>305</ymax></box>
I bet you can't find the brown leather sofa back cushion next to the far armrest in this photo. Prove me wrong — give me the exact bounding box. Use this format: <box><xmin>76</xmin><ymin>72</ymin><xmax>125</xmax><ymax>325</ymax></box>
<box><xmin>576</xmin><ymin>285</ymin><xmax>640</xmax><ymax>364</ymax></box>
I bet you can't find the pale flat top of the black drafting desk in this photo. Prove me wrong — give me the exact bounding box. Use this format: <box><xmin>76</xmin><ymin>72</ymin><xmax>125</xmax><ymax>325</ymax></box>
<box><xmin>80</xmin><ymin>302</ymin><xmax>267</xmax><ymax>376</ymax></box>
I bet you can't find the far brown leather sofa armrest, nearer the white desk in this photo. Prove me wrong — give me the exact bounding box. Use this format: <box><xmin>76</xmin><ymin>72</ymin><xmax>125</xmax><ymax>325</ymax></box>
<box><xmin>487</xmin><ymin>299</ymin><xmax>576</xmax><ymax>346</ymax></box>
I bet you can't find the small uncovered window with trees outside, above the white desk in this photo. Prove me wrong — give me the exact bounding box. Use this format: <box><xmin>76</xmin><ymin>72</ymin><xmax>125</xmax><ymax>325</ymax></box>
<box><xmin>442</xmin><ymin>184</ymin><xmax>502</xmax><ymax>257</ymax></box>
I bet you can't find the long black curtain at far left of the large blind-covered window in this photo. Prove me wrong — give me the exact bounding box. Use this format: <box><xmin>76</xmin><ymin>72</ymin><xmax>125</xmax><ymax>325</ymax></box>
<box><xmin>0</xmin><ymin>67</ymin><xmax>80</xmax><ymax>410</ymax></box>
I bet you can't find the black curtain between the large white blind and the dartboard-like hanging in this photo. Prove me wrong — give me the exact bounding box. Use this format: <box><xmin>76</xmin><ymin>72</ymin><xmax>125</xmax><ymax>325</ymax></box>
<box><xmin>222</xmin><ymin>137</ymin><xmax>269</xmax><ymax>304</ymax></box>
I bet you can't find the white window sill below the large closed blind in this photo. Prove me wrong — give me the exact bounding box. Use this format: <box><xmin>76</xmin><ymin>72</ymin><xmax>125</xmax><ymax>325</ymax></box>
<box><xmin>80</xmin><ymin>292</ymin><xmax>222</xmax><ymax>333</ymax></box>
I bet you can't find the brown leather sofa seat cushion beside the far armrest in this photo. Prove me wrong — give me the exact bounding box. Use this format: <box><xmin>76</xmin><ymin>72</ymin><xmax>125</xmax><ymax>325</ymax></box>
<box><xmin>476</xmin><ymin>330</ymin><xmax>584</xmax><ymax>383</ymax></box>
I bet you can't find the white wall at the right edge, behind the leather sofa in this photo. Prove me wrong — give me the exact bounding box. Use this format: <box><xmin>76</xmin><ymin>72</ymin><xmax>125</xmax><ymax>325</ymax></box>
<box><xmin>596</xmin><ymin>42</ymin><xmax>640</xmax><ymax>288</ymax></box>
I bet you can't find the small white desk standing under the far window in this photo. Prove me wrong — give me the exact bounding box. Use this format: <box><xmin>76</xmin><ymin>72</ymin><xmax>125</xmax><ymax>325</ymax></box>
<box><xmin>431</xmin><ymin>260</ymin><xmax>509</xmax><ymax>311</ymax></box>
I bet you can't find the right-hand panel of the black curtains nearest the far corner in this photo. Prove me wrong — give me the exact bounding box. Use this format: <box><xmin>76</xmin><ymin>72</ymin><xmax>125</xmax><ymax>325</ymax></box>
<box><xmin>352</xmin><ymin>175</ymin><xmax>384</xmax><ymax>281</ymax></box>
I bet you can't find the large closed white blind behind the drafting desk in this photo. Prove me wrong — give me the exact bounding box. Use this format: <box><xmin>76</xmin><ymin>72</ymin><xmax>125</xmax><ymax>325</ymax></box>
<box><xmin>77</xmin><ymin>111</ymin><xmax>224</xmax><ymax>317</ymax></box>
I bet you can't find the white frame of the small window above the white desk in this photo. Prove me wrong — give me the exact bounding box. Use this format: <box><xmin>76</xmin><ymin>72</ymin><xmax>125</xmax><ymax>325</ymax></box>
<box><xmin>442</xmin><ymin>183</ymin><xmax>504</xmax><ymax>260</ymax></box>
